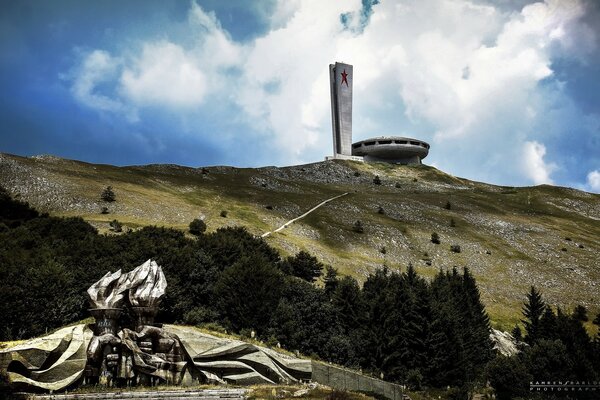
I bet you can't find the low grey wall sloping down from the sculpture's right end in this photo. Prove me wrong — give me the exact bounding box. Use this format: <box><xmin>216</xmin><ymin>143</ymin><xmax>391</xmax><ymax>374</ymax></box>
<box><xmin>312</xmin><ymin>361</ymin><xmax>403</xmax><ymax>400</ymax></box>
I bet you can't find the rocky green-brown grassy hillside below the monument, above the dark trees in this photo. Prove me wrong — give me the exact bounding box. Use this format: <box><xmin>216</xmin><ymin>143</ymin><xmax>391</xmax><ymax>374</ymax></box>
<box><xmin>0</xmin><ymin>154</ymin><xmax>600</xmax><ymax>329</ymax></box>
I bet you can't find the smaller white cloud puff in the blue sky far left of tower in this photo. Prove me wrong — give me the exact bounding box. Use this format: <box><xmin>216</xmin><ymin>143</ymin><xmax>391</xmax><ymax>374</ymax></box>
<box><xmin>72</xmin><ymin>3</ymin><xmax>242</xmax><ymax>113</ymax></box>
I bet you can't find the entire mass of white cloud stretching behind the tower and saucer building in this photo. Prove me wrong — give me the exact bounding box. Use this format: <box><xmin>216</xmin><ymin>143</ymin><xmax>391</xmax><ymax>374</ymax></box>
<box><xmin>68</xmin><ymin>0</ymin><xmax>596</xmax><ymax>184</ymax></box>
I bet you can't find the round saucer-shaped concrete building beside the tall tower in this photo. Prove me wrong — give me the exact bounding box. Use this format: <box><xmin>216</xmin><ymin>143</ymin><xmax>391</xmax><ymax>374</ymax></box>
<box><xmin>352</xmin><ymin>136</ymin><xmax>429</xmax><ymax>164</ymax></box>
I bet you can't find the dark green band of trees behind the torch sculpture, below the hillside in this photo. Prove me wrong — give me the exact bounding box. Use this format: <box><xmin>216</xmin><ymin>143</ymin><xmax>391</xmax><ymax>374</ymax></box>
<box><xmin>0</xmin><ymin>188</ymin><xmax>600</xmax><ymax>398</ymax></box>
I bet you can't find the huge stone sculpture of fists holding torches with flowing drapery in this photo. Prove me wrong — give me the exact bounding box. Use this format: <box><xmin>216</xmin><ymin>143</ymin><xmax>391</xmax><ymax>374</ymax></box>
<box><xmin>0</xmin><ymin>260</ymin><xmax>312</xmax><ymax>391</ymax></box>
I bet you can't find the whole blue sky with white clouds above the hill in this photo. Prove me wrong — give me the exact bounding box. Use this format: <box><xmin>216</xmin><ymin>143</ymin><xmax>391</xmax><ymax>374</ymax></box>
<box><xmin>0</xmin><ymin>0</ymin><xmax>600</xmax><ymax>193</ymax></box>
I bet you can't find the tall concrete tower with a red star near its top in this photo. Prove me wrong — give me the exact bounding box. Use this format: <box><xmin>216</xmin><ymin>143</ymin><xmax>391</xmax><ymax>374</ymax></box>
<box><xmin>329</xmin><ymin>62</ymin><xmax>353</xmax><ymax>158</ymax></box>
